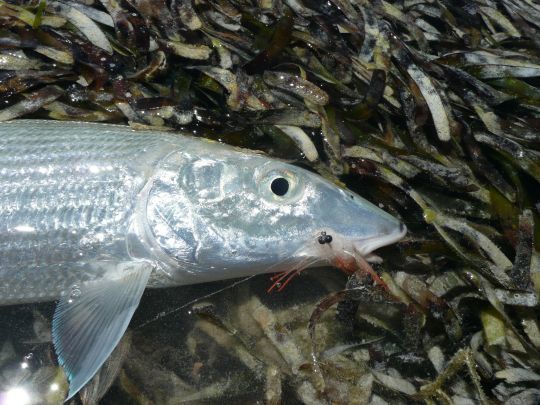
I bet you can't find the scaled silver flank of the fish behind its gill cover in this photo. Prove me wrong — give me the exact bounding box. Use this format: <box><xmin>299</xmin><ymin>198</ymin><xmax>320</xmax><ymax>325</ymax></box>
<box><xmin>0</xmin><ymin>123</ymin><xmax>178</xmax><ymax>304</ymax></box>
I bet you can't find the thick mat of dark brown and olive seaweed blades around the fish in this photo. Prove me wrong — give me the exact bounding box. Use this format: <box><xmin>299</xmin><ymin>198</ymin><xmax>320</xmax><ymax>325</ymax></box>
<box><xmin>0</xmin><ymin>0</ymin><xmax>540</xmax><ymax>403</ymax></box>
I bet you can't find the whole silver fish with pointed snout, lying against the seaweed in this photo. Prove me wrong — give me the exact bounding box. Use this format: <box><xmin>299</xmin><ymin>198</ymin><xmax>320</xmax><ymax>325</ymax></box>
<box><xmin>0</xmin><ymin>120</ymin><xmax>406</xmax><ymax>398</ymax></box>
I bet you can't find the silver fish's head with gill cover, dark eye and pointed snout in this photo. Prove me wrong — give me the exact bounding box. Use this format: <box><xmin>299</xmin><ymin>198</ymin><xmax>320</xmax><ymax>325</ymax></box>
<box><xmin>148</xmin><ymin>149</ymin><xmax>406</xmax><ymax>282</ymax></box>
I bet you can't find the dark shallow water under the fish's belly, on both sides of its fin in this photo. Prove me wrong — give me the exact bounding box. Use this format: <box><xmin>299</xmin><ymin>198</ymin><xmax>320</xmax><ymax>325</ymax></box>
<box><xmin>0</xmin><ymin>268</ymin><xmax>354</xmax><ymax>405</ymax></box>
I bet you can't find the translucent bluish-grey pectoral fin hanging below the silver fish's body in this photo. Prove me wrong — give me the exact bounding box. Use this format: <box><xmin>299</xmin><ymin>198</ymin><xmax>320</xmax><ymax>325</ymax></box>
<box><xmin>52</xmin><ymin>262</ymin><xmax>152</xmax><ymax>400</ymax></box>
